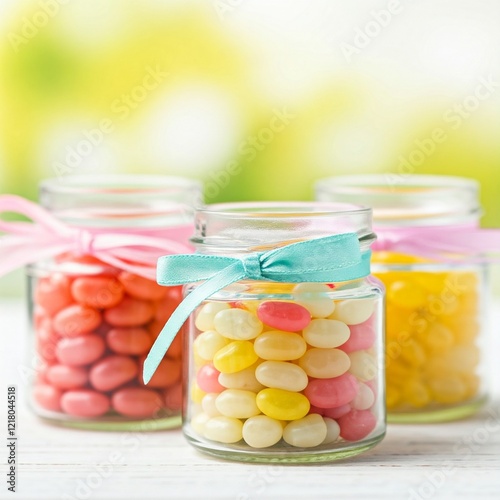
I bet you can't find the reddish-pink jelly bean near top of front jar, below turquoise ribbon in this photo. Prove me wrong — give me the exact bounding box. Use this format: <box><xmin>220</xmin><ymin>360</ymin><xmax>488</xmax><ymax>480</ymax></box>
<box><xmin>257</xmin><ymin>300</ymin><xmax>311</xmax><ymax>332</ymax></box>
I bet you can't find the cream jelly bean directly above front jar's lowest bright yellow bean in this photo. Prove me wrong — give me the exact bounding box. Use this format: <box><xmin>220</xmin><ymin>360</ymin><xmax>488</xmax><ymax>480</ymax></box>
<box><xmin>255</xmin><ymin>361</ymin><xmax>309</xmax><ymax>392</ymax></box>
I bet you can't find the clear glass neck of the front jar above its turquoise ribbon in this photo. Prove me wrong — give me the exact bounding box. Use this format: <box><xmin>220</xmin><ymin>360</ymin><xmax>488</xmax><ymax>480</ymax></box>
<box><xmin>191</xmin><ymin>202</ymin><xmax>375</xmax><ymax>255</ymax></box>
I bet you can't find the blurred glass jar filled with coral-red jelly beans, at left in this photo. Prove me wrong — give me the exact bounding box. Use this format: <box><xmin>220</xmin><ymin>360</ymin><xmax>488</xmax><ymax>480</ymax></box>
<box><xmin>28</xmin><ymin>175</ymin><xmax>200</xmax><ymax>430</ymax></box>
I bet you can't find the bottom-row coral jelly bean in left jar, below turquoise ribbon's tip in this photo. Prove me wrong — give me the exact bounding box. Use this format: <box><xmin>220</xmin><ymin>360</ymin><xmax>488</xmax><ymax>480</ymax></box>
<box><xmin>111</xmin><ymin>387</ymin><xmax>163</xmax><ymax>418</ymax></box>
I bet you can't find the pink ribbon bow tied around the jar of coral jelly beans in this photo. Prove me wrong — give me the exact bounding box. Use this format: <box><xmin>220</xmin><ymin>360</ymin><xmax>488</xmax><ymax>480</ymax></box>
<box><xmin>0</xmin><ymin>195</ymin><xmax>193</xmax><ymax>281</ymax></box>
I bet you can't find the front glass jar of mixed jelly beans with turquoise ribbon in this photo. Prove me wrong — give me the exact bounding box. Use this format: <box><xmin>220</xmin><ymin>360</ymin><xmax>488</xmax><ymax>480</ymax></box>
<box><xmin>144</xmin><ymin>203</ymin><xmax>385</xmax><ymax>463</ymax></box>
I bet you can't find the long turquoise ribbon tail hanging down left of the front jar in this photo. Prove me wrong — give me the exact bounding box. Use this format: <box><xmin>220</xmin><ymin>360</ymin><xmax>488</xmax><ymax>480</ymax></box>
<box><xmin>142</xmin><ymin>261</ymin><xmax>246</xmax><ymax>384</ymax></box>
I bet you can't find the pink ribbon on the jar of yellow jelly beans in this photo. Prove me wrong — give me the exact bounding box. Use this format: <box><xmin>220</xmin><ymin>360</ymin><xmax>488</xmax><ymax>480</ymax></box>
<box><xmin>372</xmin><ymin>224</ymin><xmax>500</xmax><ymax>262</ymax></box>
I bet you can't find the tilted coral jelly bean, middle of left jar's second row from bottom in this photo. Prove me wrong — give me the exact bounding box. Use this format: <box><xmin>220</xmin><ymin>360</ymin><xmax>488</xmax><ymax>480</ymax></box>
<box><xmin>89</xmin><ymin>356</ymin><xmax>138</xmax><ymax>391</ymax></box>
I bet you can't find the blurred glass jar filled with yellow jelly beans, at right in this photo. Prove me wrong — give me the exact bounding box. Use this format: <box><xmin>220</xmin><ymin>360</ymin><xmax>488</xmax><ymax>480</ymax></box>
<box><xmin>317</xmin><ymin>175</ymin><xmax>488</xmax><ymax>423</ymax></box>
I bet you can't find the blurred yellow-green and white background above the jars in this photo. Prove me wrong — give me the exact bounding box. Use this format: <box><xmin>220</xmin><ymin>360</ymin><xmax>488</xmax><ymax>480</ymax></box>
<box><xmin>0</xmin><ymin>0</ymin><xmax>500</xmax><ymax>294</ymax></box>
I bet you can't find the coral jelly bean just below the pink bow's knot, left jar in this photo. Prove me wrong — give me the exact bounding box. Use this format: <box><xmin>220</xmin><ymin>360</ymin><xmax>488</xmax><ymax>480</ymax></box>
<box><xmin>71</xmin><ymin>276</ymin><xmax>124</xmax><ymax>309</ymax></box>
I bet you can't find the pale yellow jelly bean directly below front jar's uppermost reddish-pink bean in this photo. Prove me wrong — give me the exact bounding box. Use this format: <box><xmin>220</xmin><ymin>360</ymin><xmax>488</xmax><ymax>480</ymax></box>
<box><xmin>254</xmin><ymin>330</ymin><xmax>307</xmax><ymax>361</ymax></box>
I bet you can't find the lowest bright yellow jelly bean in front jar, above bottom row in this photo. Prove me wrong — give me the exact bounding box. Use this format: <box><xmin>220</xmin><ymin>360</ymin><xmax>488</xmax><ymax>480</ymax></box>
<box><xmin>256</xmin><ymin>389</ymin><xmax>311</xmax><ymax>420</ymax></box>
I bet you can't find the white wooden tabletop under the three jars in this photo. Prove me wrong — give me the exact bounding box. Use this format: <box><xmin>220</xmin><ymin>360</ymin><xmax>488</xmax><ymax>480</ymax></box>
<box><xmin>0</xmin><ymin>301</ymin><xmax>500</xmax><ymax>500</ymax></box>
